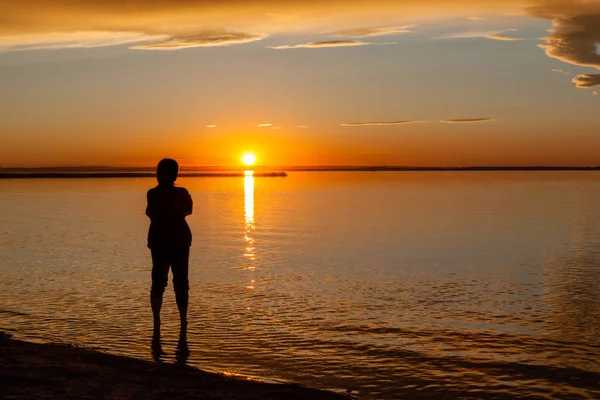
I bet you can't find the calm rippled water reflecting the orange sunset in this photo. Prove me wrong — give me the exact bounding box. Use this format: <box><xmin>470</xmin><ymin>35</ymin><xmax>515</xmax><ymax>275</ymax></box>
<box><xmin>0</xmin><ymin>172</ymin><xmax>600</xmax><ymax>399</ymax></box>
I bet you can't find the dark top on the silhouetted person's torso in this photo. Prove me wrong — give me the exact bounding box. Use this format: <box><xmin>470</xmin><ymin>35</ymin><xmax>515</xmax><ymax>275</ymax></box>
<box><xmin>146</xmin><ymin>185</ymin><xmax>193</xmax><ymax>250</ymax></box>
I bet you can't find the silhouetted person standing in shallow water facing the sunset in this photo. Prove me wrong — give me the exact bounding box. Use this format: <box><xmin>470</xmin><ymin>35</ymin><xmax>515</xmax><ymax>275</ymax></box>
<box><xmin>146</xmin><ymin>158</ymin><xmax>193</xmax><ymax>349</ymax></box>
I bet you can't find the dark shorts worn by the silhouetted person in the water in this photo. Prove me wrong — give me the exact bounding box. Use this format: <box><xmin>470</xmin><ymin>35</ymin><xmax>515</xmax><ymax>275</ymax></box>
<box><xmin>150</xmin><ymin>247</ymin><xmax>190</xmax><ymax>296</ymax></box>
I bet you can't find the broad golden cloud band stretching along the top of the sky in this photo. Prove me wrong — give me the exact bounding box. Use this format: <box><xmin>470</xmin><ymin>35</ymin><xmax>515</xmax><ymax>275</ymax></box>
<box><xmin>0</xmin><ymin>0</ymin><xmax>519</xmax><ymax>51</ymax></box>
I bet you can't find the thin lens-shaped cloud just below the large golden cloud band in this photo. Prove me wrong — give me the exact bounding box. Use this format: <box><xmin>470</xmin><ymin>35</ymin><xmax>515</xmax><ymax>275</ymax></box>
<box><xmin>131</xmin><ymin>32</ymin><xmax>267</xmax><ymax>50</ymax></box>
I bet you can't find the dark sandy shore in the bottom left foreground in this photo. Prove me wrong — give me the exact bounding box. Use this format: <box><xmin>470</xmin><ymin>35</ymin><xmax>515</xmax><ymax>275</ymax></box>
<box><xmin>0</xmin><ymin>332</ymin><xmax>349</xmax><ymax>400</ymax></box>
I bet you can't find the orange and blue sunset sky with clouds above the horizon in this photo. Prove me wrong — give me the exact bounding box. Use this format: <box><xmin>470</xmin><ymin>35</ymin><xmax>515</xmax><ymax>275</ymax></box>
<box><xmin>0</xmin><ymin>0</ymin><xmax>600</xmax><ymax>167</ymax></box>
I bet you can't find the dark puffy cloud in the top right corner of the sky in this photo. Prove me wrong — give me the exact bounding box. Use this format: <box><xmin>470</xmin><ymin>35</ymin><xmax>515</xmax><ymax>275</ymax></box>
<box><xmin>529</xmin><ymin>0</ymin><xmax>600</xmax><ymax>88</ymax></box>
